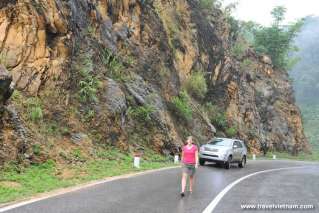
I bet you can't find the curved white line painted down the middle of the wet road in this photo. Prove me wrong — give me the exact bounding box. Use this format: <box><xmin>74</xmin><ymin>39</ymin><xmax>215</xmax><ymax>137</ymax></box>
<box><xmin>202</xmin><ymin>166</ymin><xmax>309</xmax><ymax>213</ymax></box>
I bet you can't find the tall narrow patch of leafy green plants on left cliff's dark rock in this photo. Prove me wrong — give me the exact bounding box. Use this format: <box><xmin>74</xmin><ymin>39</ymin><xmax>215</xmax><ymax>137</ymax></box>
<box><xmin>79</xmin><ymin>54</ymin><xmax>101</xmax><ymax>103</ymax></box>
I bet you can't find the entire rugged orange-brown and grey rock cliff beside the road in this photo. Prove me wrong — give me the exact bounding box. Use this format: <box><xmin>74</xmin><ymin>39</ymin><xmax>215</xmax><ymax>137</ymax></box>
<box><xmin>0</xmin><ymin>0</ymin><xmax>308</xmax><ymax>166</ymax></box>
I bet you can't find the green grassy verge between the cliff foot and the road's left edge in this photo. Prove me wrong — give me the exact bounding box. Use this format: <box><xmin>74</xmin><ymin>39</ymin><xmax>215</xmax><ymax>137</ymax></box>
<box><xmin>0</xmin><ymin>149</ymin><xmax>173</xmax><ymax>203</ymax></box>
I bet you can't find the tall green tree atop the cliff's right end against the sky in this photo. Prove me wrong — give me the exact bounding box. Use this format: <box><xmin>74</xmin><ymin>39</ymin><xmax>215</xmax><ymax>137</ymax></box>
<box><xmin>253</xmin><ymin>6</ymin><xmax>304</xmax><ymax>70</ymax></box>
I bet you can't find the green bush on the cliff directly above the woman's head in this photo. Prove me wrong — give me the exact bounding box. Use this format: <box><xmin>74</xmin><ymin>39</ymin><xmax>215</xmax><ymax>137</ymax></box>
<box><xmin>170</xmin><ymin>91</ymin><xmax>193</xmax><ymax>121</ymax></box>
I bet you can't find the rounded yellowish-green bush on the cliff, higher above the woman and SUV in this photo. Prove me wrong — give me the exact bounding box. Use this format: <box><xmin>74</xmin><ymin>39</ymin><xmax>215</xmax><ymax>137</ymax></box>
<box><xmin>185</xmin><ymin>72</ymin><xmax>207</xmax><ymax>99</ymax></box>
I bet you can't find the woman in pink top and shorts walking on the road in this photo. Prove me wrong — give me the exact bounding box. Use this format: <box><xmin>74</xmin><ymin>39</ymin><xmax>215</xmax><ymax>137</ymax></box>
<box><xmin>181</xmin><ymin>136</ymin><xmax>198</xmax><ymax>197</ymax></box>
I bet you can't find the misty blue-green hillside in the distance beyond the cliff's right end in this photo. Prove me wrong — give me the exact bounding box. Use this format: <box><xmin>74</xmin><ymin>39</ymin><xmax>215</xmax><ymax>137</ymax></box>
<box><xmin>290</xmin><ymin>17</ymin><xmax>319</xmax><ymax>150</ymax></box>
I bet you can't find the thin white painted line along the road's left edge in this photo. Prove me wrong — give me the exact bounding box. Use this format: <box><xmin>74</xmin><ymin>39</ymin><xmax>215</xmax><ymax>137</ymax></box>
<box><xmin>0</xmin><ymin>166</ymin><xmax>179</xmax><ymax>213</ymax></box>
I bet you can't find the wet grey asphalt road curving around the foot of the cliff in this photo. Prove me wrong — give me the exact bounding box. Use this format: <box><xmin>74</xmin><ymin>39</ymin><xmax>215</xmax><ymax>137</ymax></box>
<box><xmin>0</xmin><ymin>160</ymin><xmax>319</xmax><ymax>213</ymax></box>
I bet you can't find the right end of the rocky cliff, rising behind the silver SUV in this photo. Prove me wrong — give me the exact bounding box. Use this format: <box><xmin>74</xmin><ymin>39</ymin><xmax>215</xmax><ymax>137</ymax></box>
<box><xmin>216</xmin><ymin>51</ymin><xmax>309</xmax><ymax>154</ymax></box>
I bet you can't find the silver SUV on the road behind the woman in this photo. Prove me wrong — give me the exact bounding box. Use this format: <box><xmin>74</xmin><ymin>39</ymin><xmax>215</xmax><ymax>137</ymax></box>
<box><xmin>199</xmin><ymin>138</ymin><xmax>247</xmax><ymax>169</ymax></box>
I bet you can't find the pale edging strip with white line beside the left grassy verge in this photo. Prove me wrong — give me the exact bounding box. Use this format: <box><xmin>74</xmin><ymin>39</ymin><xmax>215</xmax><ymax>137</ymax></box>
<box><xmin>0</xmin><ymin>166</ymin><xmax>180</xmax><ymax>213</ymax></box>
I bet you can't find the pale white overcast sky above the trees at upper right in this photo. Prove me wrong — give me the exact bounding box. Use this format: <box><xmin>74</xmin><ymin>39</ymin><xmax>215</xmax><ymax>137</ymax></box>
<box><xmin>224</xmin><ymin>0</ymin><xmax>319</xmax><ymax>25</ymax></box>
